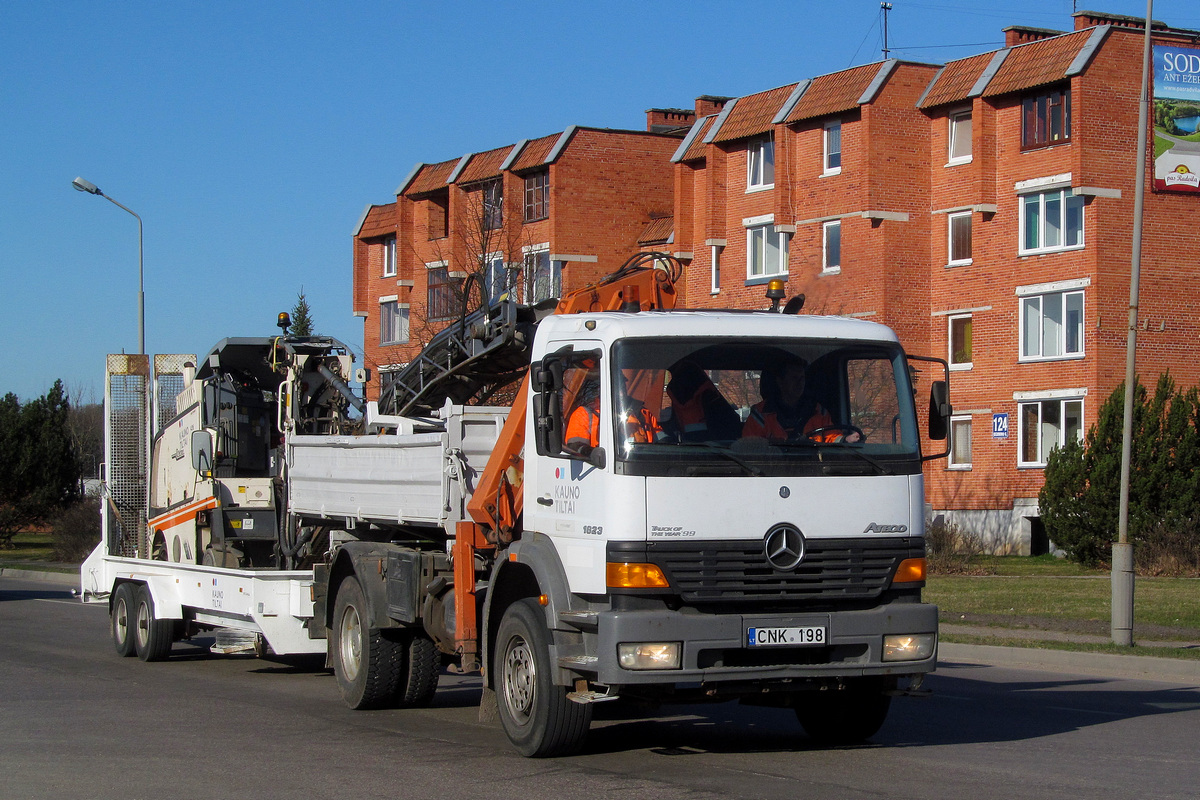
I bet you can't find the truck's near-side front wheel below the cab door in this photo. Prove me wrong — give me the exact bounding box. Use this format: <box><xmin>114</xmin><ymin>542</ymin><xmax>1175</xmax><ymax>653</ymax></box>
<box><xmin>492</xmin><ymin>599</ymin><xmax>592</xmax><ymax>758</ymax></box>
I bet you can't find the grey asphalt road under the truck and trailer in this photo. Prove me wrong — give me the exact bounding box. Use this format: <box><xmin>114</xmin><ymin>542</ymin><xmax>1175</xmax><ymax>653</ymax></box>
<box><xmin>7</xmin><ymin>577</ymin><xmax>1200</xmax><ymax>800</ymax></box>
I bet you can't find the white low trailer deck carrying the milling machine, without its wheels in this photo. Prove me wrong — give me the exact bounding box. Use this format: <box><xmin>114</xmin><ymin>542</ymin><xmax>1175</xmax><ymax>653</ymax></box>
<box><xmin>80</xmin><ymin>545</ymin><xmax>325</xmax><ymax>655</ymax></box>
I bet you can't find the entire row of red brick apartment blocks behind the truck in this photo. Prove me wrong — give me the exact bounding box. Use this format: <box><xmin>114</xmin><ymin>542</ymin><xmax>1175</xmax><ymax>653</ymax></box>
<box><xmin>354</xmin><ymin>12</ymin><xmax>1200</xmax><ymax>553</ymax></box>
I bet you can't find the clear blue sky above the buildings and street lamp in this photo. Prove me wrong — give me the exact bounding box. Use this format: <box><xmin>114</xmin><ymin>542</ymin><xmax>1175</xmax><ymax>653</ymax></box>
<box><xmin>0</xmin><ymin>0</ymin><xmax>1200</xmax><ymax>401</ymax></box>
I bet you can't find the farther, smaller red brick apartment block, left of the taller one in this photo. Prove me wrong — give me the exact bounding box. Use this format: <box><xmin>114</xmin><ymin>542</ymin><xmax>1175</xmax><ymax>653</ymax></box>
<box><xmin>354</xmin><ymin>122</ymin><xmax>694</xmax><ymax>397</ymax></box>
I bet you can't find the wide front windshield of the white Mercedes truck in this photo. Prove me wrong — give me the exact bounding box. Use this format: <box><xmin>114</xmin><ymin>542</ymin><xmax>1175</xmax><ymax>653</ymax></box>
<box><xmin>613</xmin><ymin>338</ymin><xmax>920</xmax><ymax>475</ymax></box>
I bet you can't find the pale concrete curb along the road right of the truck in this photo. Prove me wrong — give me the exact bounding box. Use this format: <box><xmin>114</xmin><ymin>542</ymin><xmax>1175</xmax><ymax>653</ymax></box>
<box><xmin>937</xmin><ymin>642</ymin><xmax>1200</xmax><ymax>685</ymax></box>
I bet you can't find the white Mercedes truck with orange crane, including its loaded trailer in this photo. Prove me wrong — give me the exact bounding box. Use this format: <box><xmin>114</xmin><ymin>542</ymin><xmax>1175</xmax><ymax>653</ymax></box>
<box><xmin>82</xmin><ymin>253</ymin><xmax>950</xmax><ymax>756</ymax></box>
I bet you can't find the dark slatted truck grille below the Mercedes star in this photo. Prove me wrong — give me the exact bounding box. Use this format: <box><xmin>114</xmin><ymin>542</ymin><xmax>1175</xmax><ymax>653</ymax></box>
<box><xmin>647</xmin><ymin>537</ymin><xmax>924</xmax><ymax>603</ymax></box>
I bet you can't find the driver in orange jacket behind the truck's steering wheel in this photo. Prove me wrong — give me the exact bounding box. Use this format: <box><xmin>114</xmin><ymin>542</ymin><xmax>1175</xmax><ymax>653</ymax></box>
<box><xmin>742</xmin><ymin>356</ymin><xmax>859</xmax><ymax>441</ymax></box>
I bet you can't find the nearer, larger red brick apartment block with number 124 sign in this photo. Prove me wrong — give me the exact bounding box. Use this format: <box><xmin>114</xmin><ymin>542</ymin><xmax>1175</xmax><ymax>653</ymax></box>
<box><xmin>672</xmin><ymin>12</ymin><xmax>1200</xmax><ymax>553</ymax></box>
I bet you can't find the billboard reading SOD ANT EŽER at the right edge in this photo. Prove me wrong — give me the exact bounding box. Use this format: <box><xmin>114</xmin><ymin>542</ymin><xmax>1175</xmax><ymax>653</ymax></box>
<box><xmin>1153</xmin><ymin>44</ymin><xmax>1200</xmax><ymax>194</ymax></box>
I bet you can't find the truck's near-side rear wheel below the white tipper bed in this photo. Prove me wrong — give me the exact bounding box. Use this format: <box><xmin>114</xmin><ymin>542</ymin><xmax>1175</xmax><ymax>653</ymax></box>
<box><xmin>329</xmin><ymin>577</ymin><xmax>404</xmax><ymax>710</ymax></box>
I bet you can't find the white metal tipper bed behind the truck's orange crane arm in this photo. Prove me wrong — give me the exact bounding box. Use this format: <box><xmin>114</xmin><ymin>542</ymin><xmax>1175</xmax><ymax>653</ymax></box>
<box><xmin>288</xmin><ymin>404</ymin><xmax>509</xmax><ymax>530</ymax></box>
